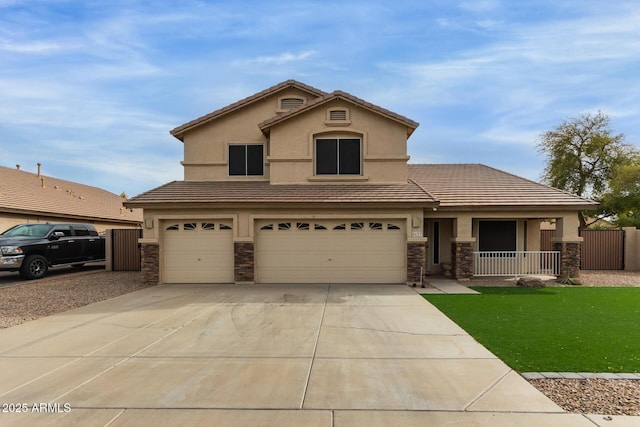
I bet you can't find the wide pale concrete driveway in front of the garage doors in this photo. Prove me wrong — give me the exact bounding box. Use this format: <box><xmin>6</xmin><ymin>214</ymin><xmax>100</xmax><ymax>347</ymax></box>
<box><xmin>0</xmin><ymin>285</ymin><xmax>594</xmax><ymax>427</ymax></box>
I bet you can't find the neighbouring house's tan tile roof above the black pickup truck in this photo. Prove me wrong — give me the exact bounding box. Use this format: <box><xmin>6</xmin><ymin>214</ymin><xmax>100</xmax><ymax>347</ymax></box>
<box><xmin>0</xmin><ymin>166</ymin><xmax>142</xmax><ymax>224</ymax></box>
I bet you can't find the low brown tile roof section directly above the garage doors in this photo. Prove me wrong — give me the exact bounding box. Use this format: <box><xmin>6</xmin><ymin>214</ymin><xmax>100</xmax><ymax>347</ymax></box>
<box><xmin>125</xmin><ymin>181</ymin><xmax>437</xmax><ymax>207</ymax></box>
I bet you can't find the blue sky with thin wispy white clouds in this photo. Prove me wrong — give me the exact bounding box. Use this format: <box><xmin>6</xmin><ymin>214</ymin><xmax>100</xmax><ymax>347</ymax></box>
<box><xmin>0</xmin><ymin>0</ymin><xmax>640</xmax><ymax>196</ymax></box>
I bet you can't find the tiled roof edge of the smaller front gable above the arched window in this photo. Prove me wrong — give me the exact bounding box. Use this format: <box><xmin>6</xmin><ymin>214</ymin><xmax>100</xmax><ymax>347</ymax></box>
<box><xmin>258</xmin><ymin>90</ymin><xmax>419</xmax><ymax>136</ymax></box>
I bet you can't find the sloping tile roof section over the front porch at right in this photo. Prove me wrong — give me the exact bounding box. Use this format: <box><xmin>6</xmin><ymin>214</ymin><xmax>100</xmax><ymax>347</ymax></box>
<box><xmin>408</xmin><ymin>164</ymin><xmax>598</xmax><ymax>210</ymax></box>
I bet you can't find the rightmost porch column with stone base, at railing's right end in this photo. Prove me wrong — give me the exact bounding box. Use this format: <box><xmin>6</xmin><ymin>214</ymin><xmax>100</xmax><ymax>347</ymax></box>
<box><xmin>551</xmin><ymin>216</ymin><xmax>582</xmax><ymax>277</ymax></box>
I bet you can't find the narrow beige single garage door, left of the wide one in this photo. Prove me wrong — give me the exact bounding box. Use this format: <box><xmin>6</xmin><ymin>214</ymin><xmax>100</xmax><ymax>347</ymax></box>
<box><xmin>162</xmin><ymin>220</ymin><xmax>234</xmax><ymax>283</ymax></box>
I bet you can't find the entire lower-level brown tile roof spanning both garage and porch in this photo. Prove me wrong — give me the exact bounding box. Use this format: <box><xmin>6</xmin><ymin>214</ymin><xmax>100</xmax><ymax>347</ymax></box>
<box><xmin>125</xmin><ymin>164</ymin><xmax>597</xmax><ymax>210</ymax></box>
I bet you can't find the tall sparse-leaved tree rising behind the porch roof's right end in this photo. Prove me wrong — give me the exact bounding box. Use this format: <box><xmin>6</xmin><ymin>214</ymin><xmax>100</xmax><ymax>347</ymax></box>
<box><xmin>538</xmin><ymin>111</ymin><xmax>636</xmax><ymax>228</ymax></box>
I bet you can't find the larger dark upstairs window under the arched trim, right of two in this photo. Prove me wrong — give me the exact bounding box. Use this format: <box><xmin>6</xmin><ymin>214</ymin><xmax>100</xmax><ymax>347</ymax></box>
<box><xmin>315</xmin><ymin>138</ymin><xmax>362</xmax><ymax>175</ymax></box>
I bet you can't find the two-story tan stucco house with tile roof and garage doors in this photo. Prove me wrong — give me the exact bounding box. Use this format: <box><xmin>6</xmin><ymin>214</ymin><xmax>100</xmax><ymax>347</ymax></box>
<box><xmin>126</xmin><ymin>80</ymin><xmax>595</xmax><ymax>284</ymax></box>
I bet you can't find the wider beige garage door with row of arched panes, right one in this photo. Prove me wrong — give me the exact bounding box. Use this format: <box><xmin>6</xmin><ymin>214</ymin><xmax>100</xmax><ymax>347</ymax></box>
<box><xmin>255</xmin><ymin>220</ymin><xmax>406</xmax><ymax>283</ymax></box>
